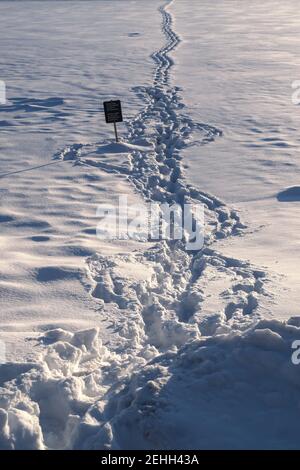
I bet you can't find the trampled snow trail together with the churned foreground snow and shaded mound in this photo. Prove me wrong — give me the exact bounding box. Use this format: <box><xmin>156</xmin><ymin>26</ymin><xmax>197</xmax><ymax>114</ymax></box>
<box><xmin>0</xmin><ymin>2</ymin><xmax>300</xmax><ymax>449</ymax></box>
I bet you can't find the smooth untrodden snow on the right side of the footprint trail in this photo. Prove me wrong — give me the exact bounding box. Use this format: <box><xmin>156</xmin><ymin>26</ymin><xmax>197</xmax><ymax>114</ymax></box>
<box><xmin>172</xmin><ymin>0</ymin><xmax>300</xmax><ymax>319</ymax></box>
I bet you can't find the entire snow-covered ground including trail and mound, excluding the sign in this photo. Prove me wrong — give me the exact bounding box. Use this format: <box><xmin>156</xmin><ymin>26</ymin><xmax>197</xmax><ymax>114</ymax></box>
<box><xmin>0</xmin><ymin>0</ymin><xmax>300</xmax><ymax>449</ymax></box>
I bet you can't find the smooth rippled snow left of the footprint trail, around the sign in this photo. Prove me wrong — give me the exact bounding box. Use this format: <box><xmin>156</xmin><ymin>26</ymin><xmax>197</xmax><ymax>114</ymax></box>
<box><xmin>0</xmin><ymin>1</ymin><xmax>162</xmax><ymax>359</ymax></box>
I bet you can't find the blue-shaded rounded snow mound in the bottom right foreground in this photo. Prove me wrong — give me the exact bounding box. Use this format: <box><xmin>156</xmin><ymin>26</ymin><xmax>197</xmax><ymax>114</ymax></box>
<box><xmin>98</xmin><ymin>321</ymin><xmax>300</xmax><ymax>449</ymax></box>
